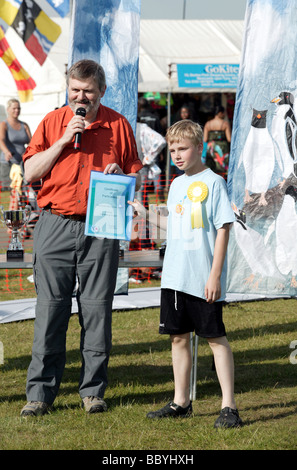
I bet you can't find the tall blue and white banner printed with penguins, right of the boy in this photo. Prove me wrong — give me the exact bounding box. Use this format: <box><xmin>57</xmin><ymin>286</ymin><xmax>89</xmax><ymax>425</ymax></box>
<box><xmin>228</xmin><ymin>0</ymin><xmax>297</xmax><ymax>297</ymax></box>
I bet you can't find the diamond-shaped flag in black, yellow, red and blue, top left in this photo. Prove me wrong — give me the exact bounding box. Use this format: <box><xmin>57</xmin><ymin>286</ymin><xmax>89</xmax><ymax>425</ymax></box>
<box><xmin>11</xmin><ymin>0</ymin><xmax>61</xmax><ymax>65</ymax></box>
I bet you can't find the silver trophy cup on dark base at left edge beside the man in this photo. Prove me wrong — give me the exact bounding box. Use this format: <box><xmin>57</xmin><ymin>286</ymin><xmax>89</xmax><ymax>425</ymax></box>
<box><xmin>0</xmin><ymin>206</ymin><xmax>31</xmax><ymax>261</ymax></box>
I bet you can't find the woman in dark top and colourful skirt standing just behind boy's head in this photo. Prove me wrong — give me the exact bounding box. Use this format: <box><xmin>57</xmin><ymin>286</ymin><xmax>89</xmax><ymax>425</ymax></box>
<box><xmin>203</xmin><ymin>106</ymin><xmax>231</xmax><ymax>178</ymax></box>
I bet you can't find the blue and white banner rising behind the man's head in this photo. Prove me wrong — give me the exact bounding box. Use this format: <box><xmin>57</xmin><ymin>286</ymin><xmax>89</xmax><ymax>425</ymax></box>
<box><xmin>68</xmin><ymin>0</ymin><xmax>140</xmax><ymax>133</ymax></box>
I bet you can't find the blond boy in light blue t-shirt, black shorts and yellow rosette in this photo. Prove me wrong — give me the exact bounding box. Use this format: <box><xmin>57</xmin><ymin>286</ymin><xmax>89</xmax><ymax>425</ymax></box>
<box><xmin>130</xmin><ymin>120</ymin><xmax>242</xmax><ymax>428</ymax></box>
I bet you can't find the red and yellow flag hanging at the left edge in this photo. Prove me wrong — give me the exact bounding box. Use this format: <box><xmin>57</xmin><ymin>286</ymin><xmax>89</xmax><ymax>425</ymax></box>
<box><xmin>0</xmin><ymin>27</ymin><xmax>36</xmax><ymax>102</ymax></box>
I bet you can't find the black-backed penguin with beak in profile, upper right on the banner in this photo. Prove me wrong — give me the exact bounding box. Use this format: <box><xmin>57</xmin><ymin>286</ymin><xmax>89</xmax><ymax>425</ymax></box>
<box><xmin>271</xmin><ymin>91</ymin><xmax>297</xmax><ymax>187</ymax></box>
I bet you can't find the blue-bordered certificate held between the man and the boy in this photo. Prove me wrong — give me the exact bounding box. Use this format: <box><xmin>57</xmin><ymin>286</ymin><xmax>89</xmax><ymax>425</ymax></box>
<box><xmin>85</xmin><ymin>171</ymin><xmax>136</xmax><ymax>240</ymax></box>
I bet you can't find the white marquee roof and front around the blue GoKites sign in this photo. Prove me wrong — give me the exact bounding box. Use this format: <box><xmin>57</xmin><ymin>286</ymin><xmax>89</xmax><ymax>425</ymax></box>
<box><xmin>138</xmin><ymin>20</ymin><xmax>244</xmax><ymax>93</ymax></box>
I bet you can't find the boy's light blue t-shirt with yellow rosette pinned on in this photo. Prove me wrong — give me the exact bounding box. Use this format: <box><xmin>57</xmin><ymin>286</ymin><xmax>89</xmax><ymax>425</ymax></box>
<box><xmin>161</xmin><ymin>169</ymin><xmax>234</xmax><ymax>300</ymax></box>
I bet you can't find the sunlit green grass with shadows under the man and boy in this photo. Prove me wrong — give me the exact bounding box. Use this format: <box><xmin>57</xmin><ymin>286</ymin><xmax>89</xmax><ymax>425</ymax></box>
<box><xmin>0</xmin><ymin>299</ymin><xmax>297</xmax><ymax>450</ymax></box>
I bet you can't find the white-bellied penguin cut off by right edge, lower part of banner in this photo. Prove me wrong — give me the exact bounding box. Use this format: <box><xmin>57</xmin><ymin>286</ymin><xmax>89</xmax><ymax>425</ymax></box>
<box><xmin>275</xmin><ymin>186</ymin><xmax>297</xmax><ymax>288</ymax></box>
